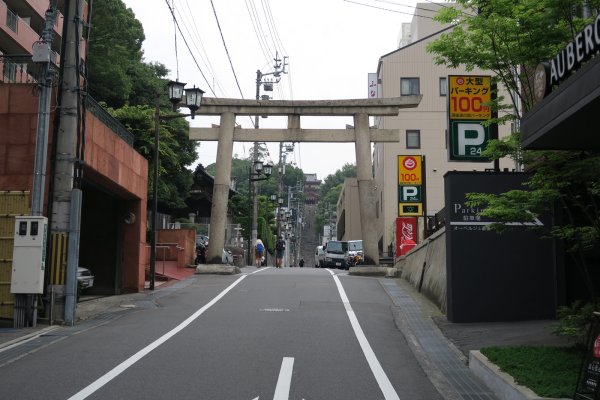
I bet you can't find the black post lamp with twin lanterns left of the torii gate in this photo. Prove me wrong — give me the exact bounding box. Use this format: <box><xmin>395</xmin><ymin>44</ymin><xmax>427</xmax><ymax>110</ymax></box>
<box><xmin>149</xmin><ymin>81</ymin><xmax>204</xmax><ymax>290</ymax></box>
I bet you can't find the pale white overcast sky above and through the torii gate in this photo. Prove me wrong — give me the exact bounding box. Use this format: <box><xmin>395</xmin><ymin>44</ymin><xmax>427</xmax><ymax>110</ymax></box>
<box><xmin>119</xmin><ymin>0</ymin><xmax>424</xmax><ymax>179</ymax></box>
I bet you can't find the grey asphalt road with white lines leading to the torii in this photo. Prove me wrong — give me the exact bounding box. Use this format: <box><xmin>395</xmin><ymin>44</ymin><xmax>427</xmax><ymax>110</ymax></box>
<box><xmin>0</xmin><ymin>268</ymin><xmax>441</xmax><ymax>400</ymax></box>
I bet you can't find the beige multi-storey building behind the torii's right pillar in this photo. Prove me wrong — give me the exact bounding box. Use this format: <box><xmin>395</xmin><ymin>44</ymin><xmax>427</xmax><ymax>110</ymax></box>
<box><xmin>373</xmin><ymin>3</ymin><xmax>514</xmax><ymax>251</ymax></box>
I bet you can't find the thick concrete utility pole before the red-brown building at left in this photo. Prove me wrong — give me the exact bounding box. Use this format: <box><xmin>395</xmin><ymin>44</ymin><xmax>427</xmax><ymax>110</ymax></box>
<box><xmin>51</xmin><ymin>0</ymin><xmax>83</xmax><ymax>325</ymax></box>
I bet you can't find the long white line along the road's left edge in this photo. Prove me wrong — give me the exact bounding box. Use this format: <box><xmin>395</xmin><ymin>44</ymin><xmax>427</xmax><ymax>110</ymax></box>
<box><xmin>68</xmin><ymin>269</ymin><xmax>264</xmax><ymax>400</ymax></box>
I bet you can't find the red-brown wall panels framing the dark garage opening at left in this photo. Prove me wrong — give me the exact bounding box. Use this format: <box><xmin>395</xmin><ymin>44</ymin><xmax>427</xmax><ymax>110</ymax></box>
<box><xmin>0</xmin><ymin>83</ymin><xmax>148</xmax><ymax>292</ymax></box>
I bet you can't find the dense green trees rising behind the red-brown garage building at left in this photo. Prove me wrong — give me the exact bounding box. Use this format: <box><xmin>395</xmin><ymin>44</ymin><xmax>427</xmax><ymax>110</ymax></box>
<box><xmin>87</xmin><ymin>0</ymin><xmax>198</xmax><ymax>212</ymax></box>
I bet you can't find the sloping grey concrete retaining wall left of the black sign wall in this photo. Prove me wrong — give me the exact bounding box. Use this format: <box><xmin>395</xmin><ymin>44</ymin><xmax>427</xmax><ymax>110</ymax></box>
<box><xmin>396</xmin><ymin>228</ymin><xmax>446</xmax><ymax>313</ymax></box>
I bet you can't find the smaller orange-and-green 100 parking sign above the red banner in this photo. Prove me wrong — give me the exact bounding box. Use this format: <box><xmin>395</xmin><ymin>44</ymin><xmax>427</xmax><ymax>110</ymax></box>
<box><xmin>398</xmin><ymin>156</ymin><xmax>424</xmax><ymax>217</ymax></box>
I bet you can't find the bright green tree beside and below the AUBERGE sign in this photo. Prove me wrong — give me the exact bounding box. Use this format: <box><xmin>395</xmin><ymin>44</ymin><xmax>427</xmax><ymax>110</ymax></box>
<box><xmin>428</xmin><ymin>0</ymin><xmax>600</xmax><ymax>299</ymax></box>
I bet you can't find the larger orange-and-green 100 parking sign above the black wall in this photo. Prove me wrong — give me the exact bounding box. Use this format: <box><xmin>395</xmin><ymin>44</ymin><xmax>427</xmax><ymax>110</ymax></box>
<box><xmin>448</xmin><ymin>75</ymin><xmax>492</xmax><ymax>162</ymax></box>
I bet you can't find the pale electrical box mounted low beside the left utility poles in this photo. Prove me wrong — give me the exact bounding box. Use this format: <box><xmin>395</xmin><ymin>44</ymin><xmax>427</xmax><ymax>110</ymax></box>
<box><xmin>10</xmin><ymin>216</ymin><xmax>48</xmax><ymax>294</ymax></box>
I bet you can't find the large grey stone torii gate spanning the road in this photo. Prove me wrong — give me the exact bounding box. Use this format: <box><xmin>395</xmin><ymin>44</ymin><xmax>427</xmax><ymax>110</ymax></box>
<box><xmin>190</xmin><ymin>95</ymin><xmax>422</xmax><ymax>265</ymax></box>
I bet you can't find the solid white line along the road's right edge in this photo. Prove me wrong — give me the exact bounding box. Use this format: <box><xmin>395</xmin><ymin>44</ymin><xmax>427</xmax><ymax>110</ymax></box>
<box><xmin>327</xmin><ymin>269</ymin><xmax>400</xmax><ymax>400</ymax></box>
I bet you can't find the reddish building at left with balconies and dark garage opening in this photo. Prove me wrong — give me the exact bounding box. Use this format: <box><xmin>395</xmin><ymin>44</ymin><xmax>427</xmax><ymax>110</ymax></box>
<box><xmin>0</xmin><ymin>0</ymin><xmax>148</xmax><ymax>318</ymax></box>
